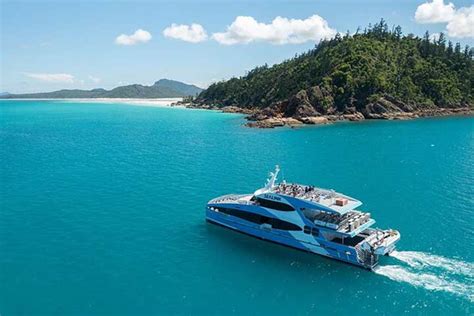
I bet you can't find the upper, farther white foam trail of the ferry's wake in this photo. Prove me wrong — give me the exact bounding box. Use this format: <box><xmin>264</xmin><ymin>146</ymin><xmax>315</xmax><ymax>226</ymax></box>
<box><xmin>390</xmin><ymin>251</ymin><xmax>474</xmax><ymax>278</ymax></box>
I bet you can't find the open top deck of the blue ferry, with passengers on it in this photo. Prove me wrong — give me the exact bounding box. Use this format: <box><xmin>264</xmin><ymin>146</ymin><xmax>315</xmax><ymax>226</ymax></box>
<box><xmin>269</xmin><ymin>182</ymin><xmax>362</xmax><ymax>215</ymax></box>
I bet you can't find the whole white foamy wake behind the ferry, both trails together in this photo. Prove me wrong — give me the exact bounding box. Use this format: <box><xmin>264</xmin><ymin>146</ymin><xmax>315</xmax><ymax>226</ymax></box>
<box><xmin>374</xmin><ymin>251</ymin><xmax>474</xmax><ymax>302</ymax></box>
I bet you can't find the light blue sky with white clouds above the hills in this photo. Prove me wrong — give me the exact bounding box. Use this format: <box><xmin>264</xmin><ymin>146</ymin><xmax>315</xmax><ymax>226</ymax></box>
<box><xmin>0</xmin><ymin>0</ymin><xmax>474</xmax><ymax>93</ymax></box>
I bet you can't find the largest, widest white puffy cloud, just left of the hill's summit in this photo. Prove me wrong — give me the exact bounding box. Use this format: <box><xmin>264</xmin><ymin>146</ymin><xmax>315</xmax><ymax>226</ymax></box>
<box><xmin>212</xmin><ymin>15</ymin><xmax>336</xmax><ymax>45</ymax></box>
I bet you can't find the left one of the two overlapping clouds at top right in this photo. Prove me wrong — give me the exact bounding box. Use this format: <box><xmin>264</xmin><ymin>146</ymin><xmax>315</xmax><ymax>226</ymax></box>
<box><xmin>415</xmin><ymin>0</ymin><xmax>455</xmax><ymax>23</ymax></box>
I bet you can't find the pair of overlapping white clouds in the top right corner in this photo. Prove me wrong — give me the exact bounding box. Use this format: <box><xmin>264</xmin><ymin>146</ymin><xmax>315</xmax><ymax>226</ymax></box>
<box><xmin>415</xmin><ymin>0</ymin><xmax>474</xmax><ymax>38</ymax></box>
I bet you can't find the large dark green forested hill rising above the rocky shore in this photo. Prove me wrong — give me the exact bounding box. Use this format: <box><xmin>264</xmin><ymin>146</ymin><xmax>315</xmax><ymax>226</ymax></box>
<box><xmin>195</xmin><ymin>20</ymin><xmax>474</xmax><ymax>117</ymax></box>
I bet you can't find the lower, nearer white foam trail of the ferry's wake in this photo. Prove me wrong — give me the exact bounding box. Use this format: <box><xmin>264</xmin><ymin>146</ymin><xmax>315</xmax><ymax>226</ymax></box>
<box><xmin>374</xmin><ymin>265</ymin><xmax>474</xmax><ymax>302</ymax></box>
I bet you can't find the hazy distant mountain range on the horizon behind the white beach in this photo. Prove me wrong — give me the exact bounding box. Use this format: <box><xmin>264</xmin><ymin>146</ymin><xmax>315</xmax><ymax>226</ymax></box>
<box><xmin>0</xmin><ymin>79</ymin><xmax>202</xmax><ymax>99</ymax></box>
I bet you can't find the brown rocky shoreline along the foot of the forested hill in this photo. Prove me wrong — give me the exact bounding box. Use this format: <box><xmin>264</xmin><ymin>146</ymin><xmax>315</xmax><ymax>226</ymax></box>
<box><xmin>181</xmin><ymin>95</ymin><xmax>474</xmax><ymax>128</ymax></box>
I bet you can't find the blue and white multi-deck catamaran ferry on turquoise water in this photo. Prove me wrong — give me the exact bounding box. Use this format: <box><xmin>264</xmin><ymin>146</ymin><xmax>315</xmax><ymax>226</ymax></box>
<box><xmin>206</xmin><ymin>166</ymin><xmax>400</xmax><ymax>269</ymax></box>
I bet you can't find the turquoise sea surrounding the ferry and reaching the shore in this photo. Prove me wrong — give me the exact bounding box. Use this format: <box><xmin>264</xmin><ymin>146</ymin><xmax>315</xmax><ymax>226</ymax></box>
<box><xmin>0</xmin><ymin>101</ymin><xmax>474</xmax><ymax>316</ymax></box>
